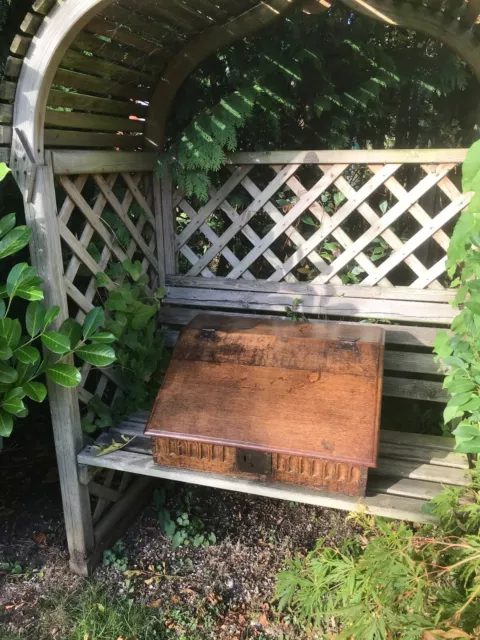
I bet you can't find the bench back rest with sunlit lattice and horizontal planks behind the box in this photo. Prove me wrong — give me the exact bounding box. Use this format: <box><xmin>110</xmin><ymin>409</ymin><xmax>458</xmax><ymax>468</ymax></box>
<box><xmin>161</xmin><ymin>150</ymin><xmax>470</xmax><ymax>402</ymax></box>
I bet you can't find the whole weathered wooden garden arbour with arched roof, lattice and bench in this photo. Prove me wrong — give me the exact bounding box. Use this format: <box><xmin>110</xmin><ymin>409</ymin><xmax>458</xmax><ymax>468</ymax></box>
<box><xmin>0</xmin><ymin>0</ymin><xmax>480</xmax><ymax>573</ymax></box>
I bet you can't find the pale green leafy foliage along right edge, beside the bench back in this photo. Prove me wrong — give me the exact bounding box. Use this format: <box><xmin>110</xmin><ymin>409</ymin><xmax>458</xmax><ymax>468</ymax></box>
<box><xmin>435</xmin><ymin>141</ymin><xmax>480</xmax><ymax>454</ymax></box>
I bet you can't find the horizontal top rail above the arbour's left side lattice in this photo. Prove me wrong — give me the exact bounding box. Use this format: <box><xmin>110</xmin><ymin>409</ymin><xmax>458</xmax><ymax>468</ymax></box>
<box><xmin>52</xmin><ymin>150</ymin><xmax>158</xmax><ymax>175</ymax></box>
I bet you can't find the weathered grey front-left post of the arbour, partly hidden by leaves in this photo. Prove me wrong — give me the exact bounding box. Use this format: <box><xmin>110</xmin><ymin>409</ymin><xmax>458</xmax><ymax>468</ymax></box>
<box><xmin>12</xmin><ymin>152</ymin><xmax>94</xmax><ymax>575</ymax></box>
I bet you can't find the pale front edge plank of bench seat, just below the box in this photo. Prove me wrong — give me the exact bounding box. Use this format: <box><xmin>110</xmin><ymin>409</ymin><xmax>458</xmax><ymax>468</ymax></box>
<box><xmin>78</xmin><ymin>448</ymin><xmax>434</xmax><ymax>522</ymax></box>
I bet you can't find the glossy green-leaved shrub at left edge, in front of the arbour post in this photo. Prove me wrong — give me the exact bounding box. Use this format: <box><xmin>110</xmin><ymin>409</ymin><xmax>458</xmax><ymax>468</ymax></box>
<box><xmin>0</xmin><ymin>165</ymin><xmax>115</xmax><ymax>438</ymax></box>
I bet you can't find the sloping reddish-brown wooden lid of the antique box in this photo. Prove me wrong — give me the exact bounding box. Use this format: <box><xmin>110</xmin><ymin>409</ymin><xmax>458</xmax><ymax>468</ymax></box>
<box><xmin>146</xmin><ymin>314</ymin><xmax>384</xmax><ymax>467</ymax></box>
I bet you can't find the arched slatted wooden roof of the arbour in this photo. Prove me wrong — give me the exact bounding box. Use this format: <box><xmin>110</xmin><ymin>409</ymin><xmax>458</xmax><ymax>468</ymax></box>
<box><xmin>0</xmin><ymin>0</ymin><xmax>480</xmax><ymax>174</ymax></box>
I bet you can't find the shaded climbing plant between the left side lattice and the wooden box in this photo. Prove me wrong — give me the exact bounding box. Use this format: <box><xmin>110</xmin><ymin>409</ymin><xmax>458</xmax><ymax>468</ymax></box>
<box><xmin>84</xmin><ymin>260</ymin><xmax>166</xmax><ymax>432</ymax></box>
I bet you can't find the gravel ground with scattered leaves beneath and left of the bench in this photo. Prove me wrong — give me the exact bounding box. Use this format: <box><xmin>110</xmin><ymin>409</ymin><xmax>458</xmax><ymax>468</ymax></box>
<box><xmin>0</xmin><ymin>440</ymin><xmax>357</xmax><ymax>640</ymax></box>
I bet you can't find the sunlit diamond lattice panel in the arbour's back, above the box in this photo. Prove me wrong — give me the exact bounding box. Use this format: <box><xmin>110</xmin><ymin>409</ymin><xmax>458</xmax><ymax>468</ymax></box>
<box><xmin>174</xmin><ymin>160</ymin><xmax>470</xmax><ymax>289</ymax></box>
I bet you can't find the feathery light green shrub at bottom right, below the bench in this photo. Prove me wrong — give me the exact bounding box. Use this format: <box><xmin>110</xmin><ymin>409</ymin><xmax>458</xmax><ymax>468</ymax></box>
<box><xmin>277</xmin><ymin>471</ymin><xmax>480</xmax><ymax>640</ymax></box>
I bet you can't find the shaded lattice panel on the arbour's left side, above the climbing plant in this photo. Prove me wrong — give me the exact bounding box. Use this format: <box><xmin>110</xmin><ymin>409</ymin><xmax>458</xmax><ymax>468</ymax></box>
<box><xmin>56</xmin><ymin>173</ymin><xmax>160</xmax><ymax>404</ymax></box>
